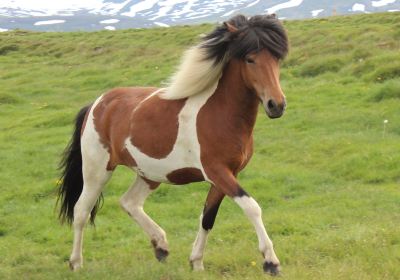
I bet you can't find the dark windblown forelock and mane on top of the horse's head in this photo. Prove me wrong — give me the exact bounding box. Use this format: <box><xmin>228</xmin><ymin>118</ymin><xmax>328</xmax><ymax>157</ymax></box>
<box><xmin>201</xmin><ymin>14</ymin><xmax>289</xmax><ymax>63</ymax></box>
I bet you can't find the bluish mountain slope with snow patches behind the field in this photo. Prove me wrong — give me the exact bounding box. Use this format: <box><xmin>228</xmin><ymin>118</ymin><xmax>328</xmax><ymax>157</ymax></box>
<box><xmin>0</xmin><ymin>0</ymin><xmax>400</xmax><ymax>31</ymax></box>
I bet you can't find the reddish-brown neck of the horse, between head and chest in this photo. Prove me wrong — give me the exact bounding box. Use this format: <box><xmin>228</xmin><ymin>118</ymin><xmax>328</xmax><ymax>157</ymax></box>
<box><xmin>211</xmin><ymin>60</ymin><xmax>259</xmax><ymax>136</ymax></box>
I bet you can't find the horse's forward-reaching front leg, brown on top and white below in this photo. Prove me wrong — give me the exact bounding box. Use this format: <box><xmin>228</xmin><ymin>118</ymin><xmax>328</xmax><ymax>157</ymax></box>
<box><xmin>208</xmin><ymin>169</ymin><xmax>280</xmax><ymax>275</ymax></box>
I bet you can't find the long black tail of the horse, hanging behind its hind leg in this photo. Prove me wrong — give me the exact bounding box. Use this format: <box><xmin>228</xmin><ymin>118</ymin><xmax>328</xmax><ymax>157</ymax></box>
<box><xmin>57</xmin><ymin>105</ymin><xmax>102</xmax><ymax>224</ymax></box>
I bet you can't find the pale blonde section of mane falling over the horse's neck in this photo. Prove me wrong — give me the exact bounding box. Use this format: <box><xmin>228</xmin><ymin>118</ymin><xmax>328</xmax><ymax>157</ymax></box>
<box><xmin>160</xmin><ymin>45</ymin><xmax>225</xmax><ymax>99</ymax></box>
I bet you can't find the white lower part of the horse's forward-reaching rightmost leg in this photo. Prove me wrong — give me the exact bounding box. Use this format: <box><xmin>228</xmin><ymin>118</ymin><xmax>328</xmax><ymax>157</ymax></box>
<box><xmin>234</xmin><ymin>195</ymin><xmax>279</xmax><ymax>266</ymax></box>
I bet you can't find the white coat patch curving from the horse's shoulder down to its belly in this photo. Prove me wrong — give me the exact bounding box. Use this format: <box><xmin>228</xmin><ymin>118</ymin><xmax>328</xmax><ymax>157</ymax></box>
<box><xmin>125</xmin><ymin>82</ymin><xmax>220</xmax><ymax>183</ymax></box>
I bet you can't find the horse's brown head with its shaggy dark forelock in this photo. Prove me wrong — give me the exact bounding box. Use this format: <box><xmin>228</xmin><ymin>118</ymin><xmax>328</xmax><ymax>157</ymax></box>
<box><xmin>203</xmin><ymin>14</ymin><xmax>288</xmax><ymax>118</ymax></box>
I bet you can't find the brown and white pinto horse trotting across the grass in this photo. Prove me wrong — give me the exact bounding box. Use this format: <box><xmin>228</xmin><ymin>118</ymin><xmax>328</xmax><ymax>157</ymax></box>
<box><xmin>59</xmin><ymin>15</ymin><xmax>288</xmax><ymax>275</ymax></box>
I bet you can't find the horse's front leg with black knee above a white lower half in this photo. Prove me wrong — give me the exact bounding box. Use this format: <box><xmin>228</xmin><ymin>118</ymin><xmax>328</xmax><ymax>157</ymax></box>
<box><xmin>190</xmin><ymin>185</ymin><xmax>225</xmax><ymax>270</ymax></box>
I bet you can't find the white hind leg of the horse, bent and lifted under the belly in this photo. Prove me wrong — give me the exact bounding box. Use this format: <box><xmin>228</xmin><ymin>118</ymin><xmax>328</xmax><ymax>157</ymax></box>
<box><xmin>120</xmin><ymin>175</ymin><xmax>168</xmax><ymax>261</ymax></box>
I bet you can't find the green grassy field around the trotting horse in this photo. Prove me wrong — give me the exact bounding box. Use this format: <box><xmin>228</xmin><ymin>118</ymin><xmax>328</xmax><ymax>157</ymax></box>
<box><xmin>0</xmin><ymin>13</ymin><xmax>400</xmax><ymax>280</ymax></box>
